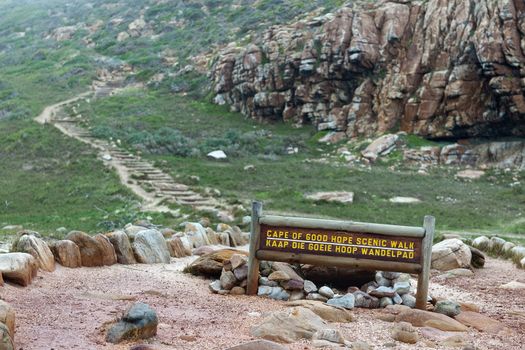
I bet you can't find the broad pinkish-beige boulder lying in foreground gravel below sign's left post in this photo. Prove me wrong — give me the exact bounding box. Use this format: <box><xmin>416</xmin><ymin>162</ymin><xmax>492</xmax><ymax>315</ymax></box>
<box><xmin>251</xmin><ymin>307</ymin><xmax>327</xmax><ymax>343</ymax></box>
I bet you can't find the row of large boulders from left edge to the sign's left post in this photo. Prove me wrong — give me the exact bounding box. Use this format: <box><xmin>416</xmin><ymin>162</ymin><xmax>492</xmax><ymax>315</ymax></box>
<box><xmin>0</xmin><ymin>223</ymin><xmax>248</xmax><ymax>286</ymax></box>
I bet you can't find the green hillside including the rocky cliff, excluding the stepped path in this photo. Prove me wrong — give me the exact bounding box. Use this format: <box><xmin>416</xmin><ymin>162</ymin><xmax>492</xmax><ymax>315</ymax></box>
<box><xmin>0</xmin><ymin>0</ymin><xmax>525</xmax><ymax>234</ymax></box>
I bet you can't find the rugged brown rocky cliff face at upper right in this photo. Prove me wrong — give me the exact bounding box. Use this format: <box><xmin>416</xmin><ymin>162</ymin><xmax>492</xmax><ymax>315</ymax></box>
<box><xmin>211</xmin><ymin>0</ymin><xmax>525</xmax><ymax>139</ymax></box>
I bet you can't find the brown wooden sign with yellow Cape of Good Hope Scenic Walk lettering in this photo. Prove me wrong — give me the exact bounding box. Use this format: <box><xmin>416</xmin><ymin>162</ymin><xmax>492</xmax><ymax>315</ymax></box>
<box><xmin>247</xmin><ymin>202</ymin><xmax>435</xmax><ymax>309</ymax></box>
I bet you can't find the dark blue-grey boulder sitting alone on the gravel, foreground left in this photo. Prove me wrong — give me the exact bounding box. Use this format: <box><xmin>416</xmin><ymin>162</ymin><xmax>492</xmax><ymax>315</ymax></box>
<box><xmin>106</xmin><ymin>303</ymin><xmax>159</xmax><ymax>344</ymax></box>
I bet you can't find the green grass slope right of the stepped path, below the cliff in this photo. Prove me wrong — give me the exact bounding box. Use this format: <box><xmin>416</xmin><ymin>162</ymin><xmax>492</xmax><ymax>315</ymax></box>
<box><xmin>82</xmin><ymin>91</ymin><xmax>525</xmax><ymax>232</ymax></box>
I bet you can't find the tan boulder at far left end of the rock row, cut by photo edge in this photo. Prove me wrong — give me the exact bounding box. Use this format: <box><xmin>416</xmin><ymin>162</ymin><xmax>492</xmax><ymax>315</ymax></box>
<box><xmin>0</xmin><ymin>253</ymin><xmax>38</xmax><ymax>287</ymax></box>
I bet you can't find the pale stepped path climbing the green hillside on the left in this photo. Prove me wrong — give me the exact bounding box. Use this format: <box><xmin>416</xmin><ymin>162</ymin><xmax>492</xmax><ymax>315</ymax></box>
<box><xmin>35</xmin><ymin>88</ymin><xmax>233</xmax><ymax>221</ymax></box>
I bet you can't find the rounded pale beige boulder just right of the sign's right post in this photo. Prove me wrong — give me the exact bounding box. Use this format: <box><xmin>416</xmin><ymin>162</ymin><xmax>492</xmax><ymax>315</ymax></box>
<box><xmin>432</xmin><ymin>238</ymin><xmax>472</xmax><ymax>271</ymax></box>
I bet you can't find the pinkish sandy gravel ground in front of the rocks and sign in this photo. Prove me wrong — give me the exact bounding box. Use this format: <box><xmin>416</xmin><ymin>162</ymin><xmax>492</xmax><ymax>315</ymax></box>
<box><xmin>0</xmin><ymin>254</ymin><xmax>525</xmax><ymax>350</ymax></box>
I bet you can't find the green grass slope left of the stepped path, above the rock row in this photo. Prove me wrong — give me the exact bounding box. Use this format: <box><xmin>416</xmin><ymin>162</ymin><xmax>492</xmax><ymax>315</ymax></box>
<box><xmin>0</xmin><ymin>121</ymin><xmax>178</xmax><ymax>236</ymax></box>
